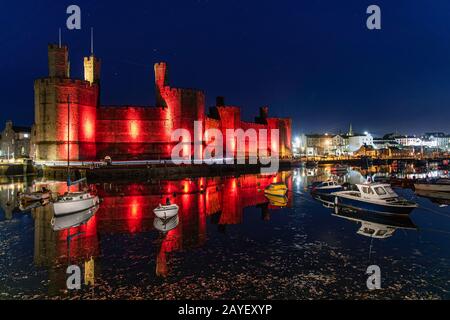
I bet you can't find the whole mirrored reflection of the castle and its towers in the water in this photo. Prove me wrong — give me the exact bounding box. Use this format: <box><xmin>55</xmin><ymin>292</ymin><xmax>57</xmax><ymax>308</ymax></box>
<box><xmin>29</xmin><ymin>172</ymin><xmax>292</xmax><ymax>290</ymax></box>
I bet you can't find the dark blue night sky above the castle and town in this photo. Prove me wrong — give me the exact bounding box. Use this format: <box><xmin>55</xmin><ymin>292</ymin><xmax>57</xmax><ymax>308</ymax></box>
<box><xmin>0</xmin><ymin>0</ymin><xmax>450</xmax><ymax>135</ymax></box>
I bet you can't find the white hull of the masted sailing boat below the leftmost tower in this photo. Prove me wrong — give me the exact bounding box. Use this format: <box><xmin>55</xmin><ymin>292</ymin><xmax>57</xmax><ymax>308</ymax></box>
<box><xmin>53</xmin><ymin>191</ymin><xmax>100</xmax><ymax>217</ymax></box>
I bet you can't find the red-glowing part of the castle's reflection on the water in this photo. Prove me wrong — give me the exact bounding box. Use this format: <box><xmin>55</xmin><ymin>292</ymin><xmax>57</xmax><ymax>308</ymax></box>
<box><xmin>44</xmin><ymin>173</ymin><xmax>292</xmax><ymax>276</ymax></box>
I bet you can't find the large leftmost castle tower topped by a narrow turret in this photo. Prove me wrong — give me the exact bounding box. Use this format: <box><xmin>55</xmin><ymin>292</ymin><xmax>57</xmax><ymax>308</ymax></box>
<box><xmin>33</xmin><ymin>45</ymin><xmax>99</xmax><ymax>160</ymax></box>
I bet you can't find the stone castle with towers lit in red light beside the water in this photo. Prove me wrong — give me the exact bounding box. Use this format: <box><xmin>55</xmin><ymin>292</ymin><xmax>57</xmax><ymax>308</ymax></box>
<box><xmin>32</xmin><ymin>44</ymin><xmax>292</xmax><ymax>161</ymax></box>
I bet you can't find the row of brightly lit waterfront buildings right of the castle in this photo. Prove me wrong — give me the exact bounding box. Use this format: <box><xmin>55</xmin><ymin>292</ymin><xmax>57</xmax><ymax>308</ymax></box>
<box><xmin>293</xmin><ymin>126</ymin><xmax>450</xmax><ymax>157</ymax></box>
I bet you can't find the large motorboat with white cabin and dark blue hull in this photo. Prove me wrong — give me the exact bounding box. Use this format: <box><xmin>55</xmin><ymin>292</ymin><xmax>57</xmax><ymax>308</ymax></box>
<box><xmin>332</xmin><ymin>183</ymin><xmax>417</xmax><ymax>215</ymax></box>
